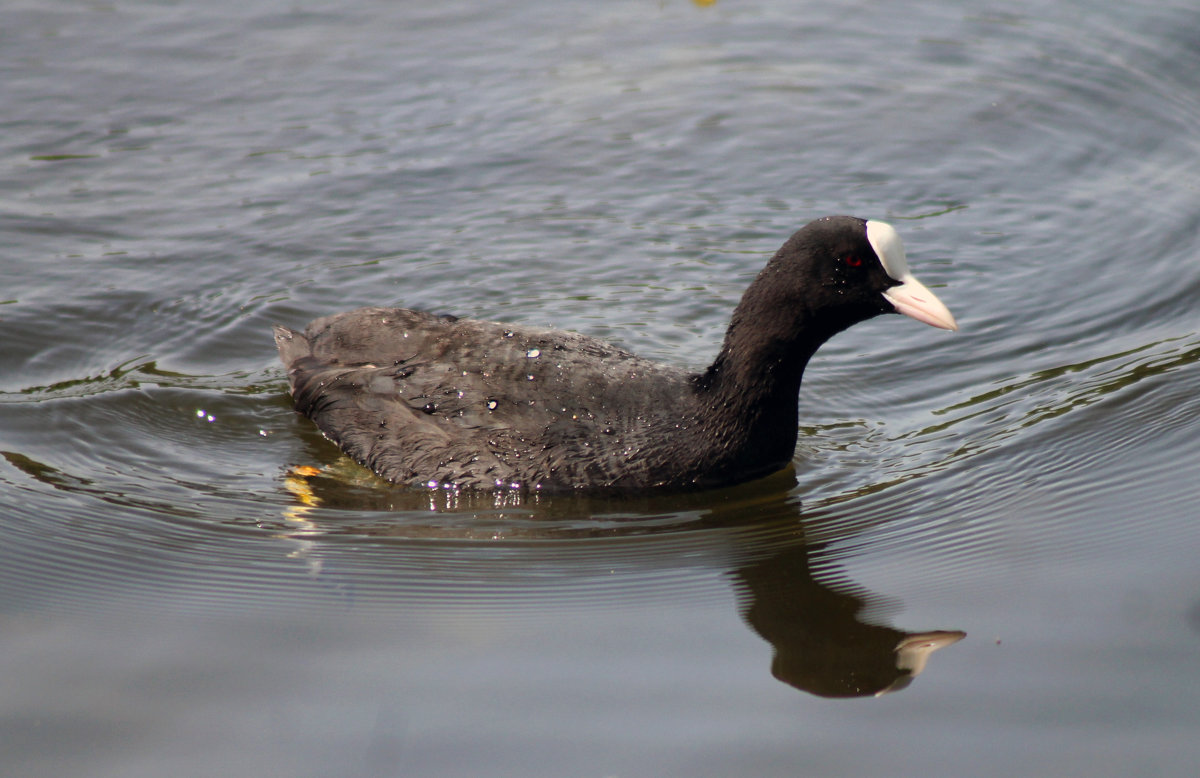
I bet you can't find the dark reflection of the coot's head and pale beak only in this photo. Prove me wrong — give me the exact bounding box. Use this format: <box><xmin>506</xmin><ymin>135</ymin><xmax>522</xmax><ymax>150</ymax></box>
<box><xmin>733</xmin><ymin>535</ymin><xmax>966</xmax><ymax>698</ymax></box>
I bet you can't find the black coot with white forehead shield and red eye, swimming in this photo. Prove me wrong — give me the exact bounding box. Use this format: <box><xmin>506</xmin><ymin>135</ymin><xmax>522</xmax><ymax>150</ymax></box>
<box><xmin>275</xmin><ymin>216</ymin><xmax>958</xmax><ymax>490</ymax></box>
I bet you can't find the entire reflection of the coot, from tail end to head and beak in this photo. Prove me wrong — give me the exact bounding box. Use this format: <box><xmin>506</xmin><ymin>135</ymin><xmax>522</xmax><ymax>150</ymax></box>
<box><xmin>281</xmin><ymin>468</ymin><xmax>966</xmax><ymax>698</ymax></box>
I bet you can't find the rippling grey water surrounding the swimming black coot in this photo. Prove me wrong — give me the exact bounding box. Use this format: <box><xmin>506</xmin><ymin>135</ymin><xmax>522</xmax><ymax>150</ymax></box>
<box><xmin>0</xmin><ymin>0</ymin><xmax>1200</xmax><ymax>777</ymax></box>
